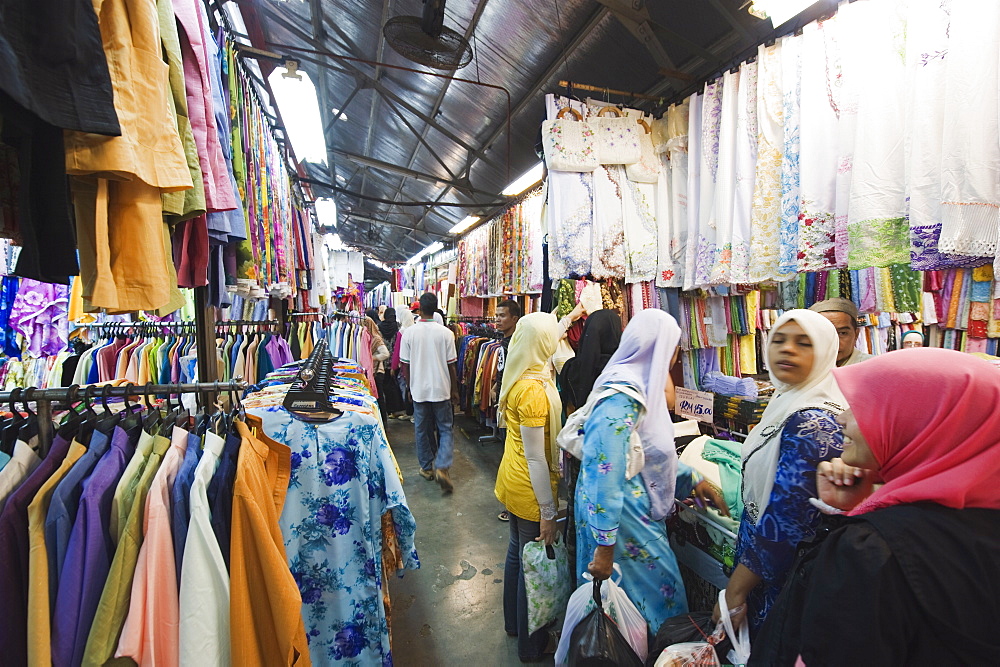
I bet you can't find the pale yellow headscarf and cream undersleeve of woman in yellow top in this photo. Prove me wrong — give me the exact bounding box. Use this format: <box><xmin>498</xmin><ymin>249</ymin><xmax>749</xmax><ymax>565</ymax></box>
<box><xmin>499</xmin><ymin>313</ymin><xmax>563</xmax><ymax>471</ymax></box>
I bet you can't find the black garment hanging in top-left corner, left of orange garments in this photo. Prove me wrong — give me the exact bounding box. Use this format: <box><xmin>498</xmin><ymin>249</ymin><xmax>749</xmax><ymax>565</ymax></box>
<box><xmin>0</xmin><ymin>0</ymin><xmax>121</xmax><ymax>136</ymax></box>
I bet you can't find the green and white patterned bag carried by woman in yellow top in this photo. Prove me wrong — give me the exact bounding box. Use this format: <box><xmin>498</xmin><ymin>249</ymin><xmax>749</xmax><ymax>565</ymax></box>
<box><xmin>521</xmin><ymin>542</ymin><xmax>570</xmax><ymax>633</ymax></box>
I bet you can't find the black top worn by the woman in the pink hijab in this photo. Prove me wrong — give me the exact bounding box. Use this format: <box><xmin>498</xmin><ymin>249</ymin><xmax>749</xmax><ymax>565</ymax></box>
<box><xmin>749</xmin><ymin>503</ymin><xmax>1000</xmax><ymax>667</ymax></box>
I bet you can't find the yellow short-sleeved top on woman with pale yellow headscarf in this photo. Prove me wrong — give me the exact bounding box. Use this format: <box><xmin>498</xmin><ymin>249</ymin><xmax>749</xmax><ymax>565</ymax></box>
<box><xmin>493</xmin><ymin>378</ymin><xmax>559</xmax><ymax>521</ymax></box>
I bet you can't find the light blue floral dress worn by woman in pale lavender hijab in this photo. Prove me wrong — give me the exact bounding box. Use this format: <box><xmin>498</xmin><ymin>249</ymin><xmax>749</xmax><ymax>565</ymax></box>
<box><xmin>575</xmin><ymin>393</ymin><xmax>701</xmax><ymax>633</ymax></box>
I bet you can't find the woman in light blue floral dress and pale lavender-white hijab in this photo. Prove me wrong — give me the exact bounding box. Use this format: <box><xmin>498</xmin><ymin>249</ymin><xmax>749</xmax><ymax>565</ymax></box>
<box><xmin>575</xmin><ymin>309</ymin><xmax>726</xmax><ymax>633</ymax></box>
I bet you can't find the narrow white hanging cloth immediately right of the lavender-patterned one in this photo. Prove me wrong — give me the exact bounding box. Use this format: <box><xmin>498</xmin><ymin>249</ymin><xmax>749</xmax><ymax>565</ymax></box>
<box><xmin>708</xmin><ymin>71</ymin><xmax>740</xmax><ymax>285</ymax></box>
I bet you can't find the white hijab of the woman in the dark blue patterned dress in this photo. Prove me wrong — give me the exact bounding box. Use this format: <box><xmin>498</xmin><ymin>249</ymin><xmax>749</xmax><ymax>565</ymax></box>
<box><xmin>743</xmin><ymin>309</ymin><xmax>848</xmax><ymax>524</ymax></box>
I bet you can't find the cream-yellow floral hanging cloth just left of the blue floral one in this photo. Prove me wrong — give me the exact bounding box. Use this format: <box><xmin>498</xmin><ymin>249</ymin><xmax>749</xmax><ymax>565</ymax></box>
<box><xmin>750</xmin><ymin>42</ymin><xmax>785</xmax><ymax>283</ymax></box>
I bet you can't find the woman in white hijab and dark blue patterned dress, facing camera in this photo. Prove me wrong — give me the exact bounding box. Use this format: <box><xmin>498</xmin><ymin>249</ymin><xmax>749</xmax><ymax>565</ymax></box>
<box><xmin>716</xmin><ymin>310</ymin><xmax>847</xmax><ymax>633</ymax></box>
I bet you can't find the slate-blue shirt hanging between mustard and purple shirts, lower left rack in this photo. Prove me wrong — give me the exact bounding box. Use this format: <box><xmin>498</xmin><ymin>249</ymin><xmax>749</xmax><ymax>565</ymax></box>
<box><xmin>45</xmin><ymin>429</ymin><xmax>111</xmax><ymax>592</ymax></box>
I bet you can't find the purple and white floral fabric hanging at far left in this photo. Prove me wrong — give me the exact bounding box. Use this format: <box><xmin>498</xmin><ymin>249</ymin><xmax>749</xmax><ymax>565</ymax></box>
<box><xmin>8</xmin><ymin>278</ymin><xmax>69</xmax><ymax>357</ymax></box>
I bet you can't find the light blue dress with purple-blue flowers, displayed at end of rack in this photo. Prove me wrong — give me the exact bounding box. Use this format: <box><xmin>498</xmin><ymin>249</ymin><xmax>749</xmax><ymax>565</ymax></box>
<box><xmin>251</xmin><ymin>406</ymin><xmax>420</xmax><ymax>665</ymax></box>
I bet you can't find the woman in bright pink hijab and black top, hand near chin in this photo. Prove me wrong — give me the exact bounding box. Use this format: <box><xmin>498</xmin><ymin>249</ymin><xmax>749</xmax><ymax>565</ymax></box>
<box><xmin>750</xmin><ymin>348</ymin><xmax>1000</xmax><ymax>667</ymax></box>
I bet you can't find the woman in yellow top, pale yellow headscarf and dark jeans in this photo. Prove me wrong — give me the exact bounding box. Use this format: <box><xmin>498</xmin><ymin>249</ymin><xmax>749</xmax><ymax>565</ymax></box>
<box><xmin>494</xmin><ymin>313</ymin><xmax>565</xmax><ymax>661</ymax></box>
